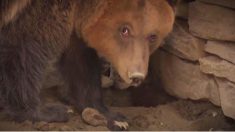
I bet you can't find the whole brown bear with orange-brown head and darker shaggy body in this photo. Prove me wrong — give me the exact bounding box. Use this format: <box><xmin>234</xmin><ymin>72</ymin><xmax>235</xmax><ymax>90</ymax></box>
<box><xmin>0</xmin><ymin>0</ymin><xmax>174</xmax><ymax>130</ymax></box>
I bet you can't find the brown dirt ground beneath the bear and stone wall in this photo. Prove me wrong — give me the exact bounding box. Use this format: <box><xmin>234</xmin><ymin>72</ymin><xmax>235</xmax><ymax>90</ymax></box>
<box><xmin>0</xmin><ymin>82</ymin><xmax>235</xmax><ymax>131</ymax></box>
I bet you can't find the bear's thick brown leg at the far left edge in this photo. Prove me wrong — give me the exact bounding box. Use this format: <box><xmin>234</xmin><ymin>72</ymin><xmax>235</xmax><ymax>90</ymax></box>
<box><xmin>0</xmin><ymin>35</ymin><xmax>68</xmax><ymax>122</ymax></box>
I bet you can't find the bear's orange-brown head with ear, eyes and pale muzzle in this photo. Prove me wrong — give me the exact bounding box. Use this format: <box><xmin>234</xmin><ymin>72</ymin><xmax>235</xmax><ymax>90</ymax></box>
<box><xmin>82</xmin><ymin>0</ymin><xmax>174</xmax><ymax>85</ymax></box>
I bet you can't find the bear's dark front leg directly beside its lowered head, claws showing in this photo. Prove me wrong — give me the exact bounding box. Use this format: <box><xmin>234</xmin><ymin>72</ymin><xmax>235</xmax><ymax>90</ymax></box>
<box><xmin>60</xmin><ymin>35</ymin><xmax>128</xmax><ymax>130</ymax></box>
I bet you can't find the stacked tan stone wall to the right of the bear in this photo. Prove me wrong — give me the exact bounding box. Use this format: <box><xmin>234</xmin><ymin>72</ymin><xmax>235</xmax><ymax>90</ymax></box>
<box><xmin>151</xmin><ymin>0</ymin><xmax>235</xmax><ymax>119</ymax></box>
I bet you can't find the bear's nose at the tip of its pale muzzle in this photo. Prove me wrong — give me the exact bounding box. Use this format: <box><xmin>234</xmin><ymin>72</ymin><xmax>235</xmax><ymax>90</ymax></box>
<box><xmin>128</xmin><ymin>72</ymin><xmax>145</xmax><ymax>87</ymax></box>
